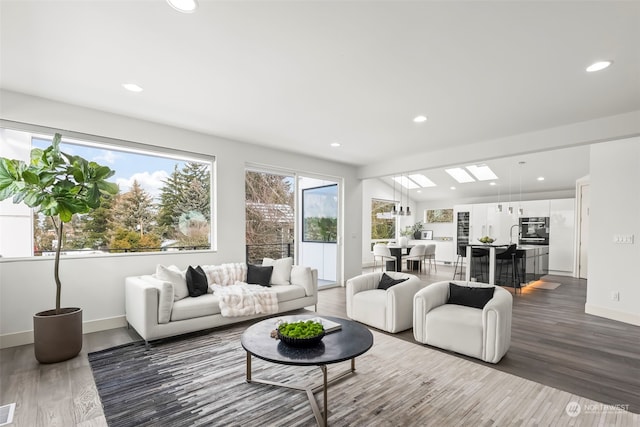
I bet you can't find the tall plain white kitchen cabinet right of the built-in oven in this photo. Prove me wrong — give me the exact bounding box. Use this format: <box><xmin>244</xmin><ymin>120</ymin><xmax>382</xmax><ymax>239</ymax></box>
<box><xmin>549</xmin><ymin>199</ymin><xmax>575</xmax><ymax>274</ymax></box>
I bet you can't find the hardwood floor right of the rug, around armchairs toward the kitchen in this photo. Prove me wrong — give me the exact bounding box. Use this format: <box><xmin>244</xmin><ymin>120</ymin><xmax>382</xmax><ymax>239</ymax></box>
<box><xmin>318</xmin><ymin>266</ymin><xmax>640</xmax><ymax>413</ymax></box>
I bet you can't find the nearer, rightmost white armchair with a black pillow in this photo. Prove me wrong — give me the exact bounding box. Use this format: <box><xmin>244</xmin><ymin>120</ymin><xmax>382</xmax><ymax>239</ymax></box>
<box><xmin>413</xmin><ymin>281</ymin><xmax>513</xmax><ymax>363</ymax></box>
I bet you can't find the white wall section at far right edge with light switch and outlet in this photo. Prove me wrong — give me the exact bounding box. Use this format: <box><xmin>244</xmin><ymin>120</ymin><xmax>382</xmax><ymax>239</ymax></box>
<box><xmin>585</xmin><ymin>137</ymin><xmax>640</xmax><ymax>325</ymax></box>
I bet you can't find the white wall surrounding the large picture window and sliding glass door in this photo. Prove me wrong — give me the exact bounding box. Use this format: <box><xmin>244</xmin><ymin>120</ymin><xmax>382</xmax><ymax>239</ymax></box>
<box><xmin>0</xmin><ymin>91</ymin><xmax>362</xmax><ymax>347</ymax></box>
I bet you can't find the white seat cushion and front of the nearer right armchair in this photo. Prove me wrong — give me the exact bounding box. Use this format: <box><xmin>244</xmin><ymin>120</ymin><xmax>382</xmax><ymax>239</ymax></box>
<box><xmin>425</xmin><ymin>304</ymin><xmax>483</xmax><ymax>358</ymax></box>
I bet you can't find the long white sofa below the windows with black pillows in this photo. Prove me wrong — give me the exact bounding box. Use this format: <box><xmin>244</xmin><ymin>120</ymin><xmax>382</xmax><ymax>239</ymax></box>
<box><xmin>125</xmin><ymin>260</ymin><xmax>318</xmax><ymax>344</ymax></box>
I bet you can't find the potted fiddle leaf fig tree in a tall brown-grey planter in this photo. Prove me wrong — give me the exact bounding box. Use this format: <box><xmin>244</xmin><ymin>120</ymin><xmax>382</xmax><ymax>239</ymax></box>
<box><xmin>0</xmin><ymin>133</ymin><xmax>118</xmax><ymax>363</ymax></box>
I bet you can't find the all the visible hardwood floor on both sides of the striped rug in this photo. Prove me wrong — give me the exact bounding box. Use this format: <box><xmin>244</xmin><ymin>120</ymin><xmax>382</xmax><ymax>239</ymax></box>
<box><xmin>0</xmin><ymin>266</ymin><xmax>640</xmax><ymax>427</ymax></box>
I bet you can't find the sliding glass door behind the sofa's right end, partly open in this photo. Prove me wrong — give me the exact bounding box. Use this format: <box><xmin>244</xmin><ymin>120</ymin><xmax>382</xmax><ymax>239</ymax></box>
<box><xmin>245</xmin><ymin>168</ymin><xmax>342</xmax><ymax>287</ymax></box>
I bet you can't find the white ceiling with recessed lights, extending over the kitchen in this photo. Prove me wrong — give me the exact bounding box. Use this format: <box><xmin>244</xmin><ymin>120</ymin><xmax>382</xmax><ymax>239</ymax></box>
<box><xmin>0</xmin><ymin>0</ymin><xmax>640</xmax><ymax>198</ymax></box>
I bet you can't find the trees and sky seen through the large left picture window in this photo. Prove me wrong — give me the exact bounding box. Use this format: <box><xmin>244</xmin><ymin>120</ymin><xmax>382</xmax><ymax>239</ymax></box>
<box><xmin>4</xmin><ymin>131</ymin><xmax>212</xmax><ymax>256</ymax></box>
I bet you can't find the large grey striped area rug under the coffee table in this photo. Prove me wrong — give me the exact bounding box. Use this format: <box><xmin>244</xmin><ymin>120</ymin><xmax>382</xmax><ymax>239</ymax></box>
<box><xmin>89</xmin><ymin>324</ymin><xmax>640</xmax><ymax>427</ymax></box>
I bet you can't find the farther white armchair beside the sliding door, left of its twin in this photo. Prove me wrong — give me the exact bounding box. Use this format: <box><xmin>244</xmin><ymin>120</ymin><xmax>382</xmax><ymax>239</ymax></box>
<box><xmin>347</xmin><ymin>272</ymin><xmax>423</xmax><ymax>333</ymax></box>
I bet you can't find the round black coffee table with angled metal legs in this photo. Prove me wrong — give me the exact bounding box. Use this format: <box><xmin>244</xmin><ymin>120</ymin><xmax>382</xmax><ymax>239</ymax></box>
<box><xmin>241</xmin><ymin>315</ymin><xmax>373</xmax><ymax>426</ymax></box>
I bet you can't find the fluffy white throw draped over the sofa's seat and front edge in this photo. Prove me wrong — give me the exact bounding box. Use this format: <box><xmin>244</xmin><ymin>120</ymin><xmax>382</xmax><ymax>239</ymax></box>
<box><xmin>209</xmin><ymin>281</ymin><xmax>278</xmax><ymax>317</ymax></box>
